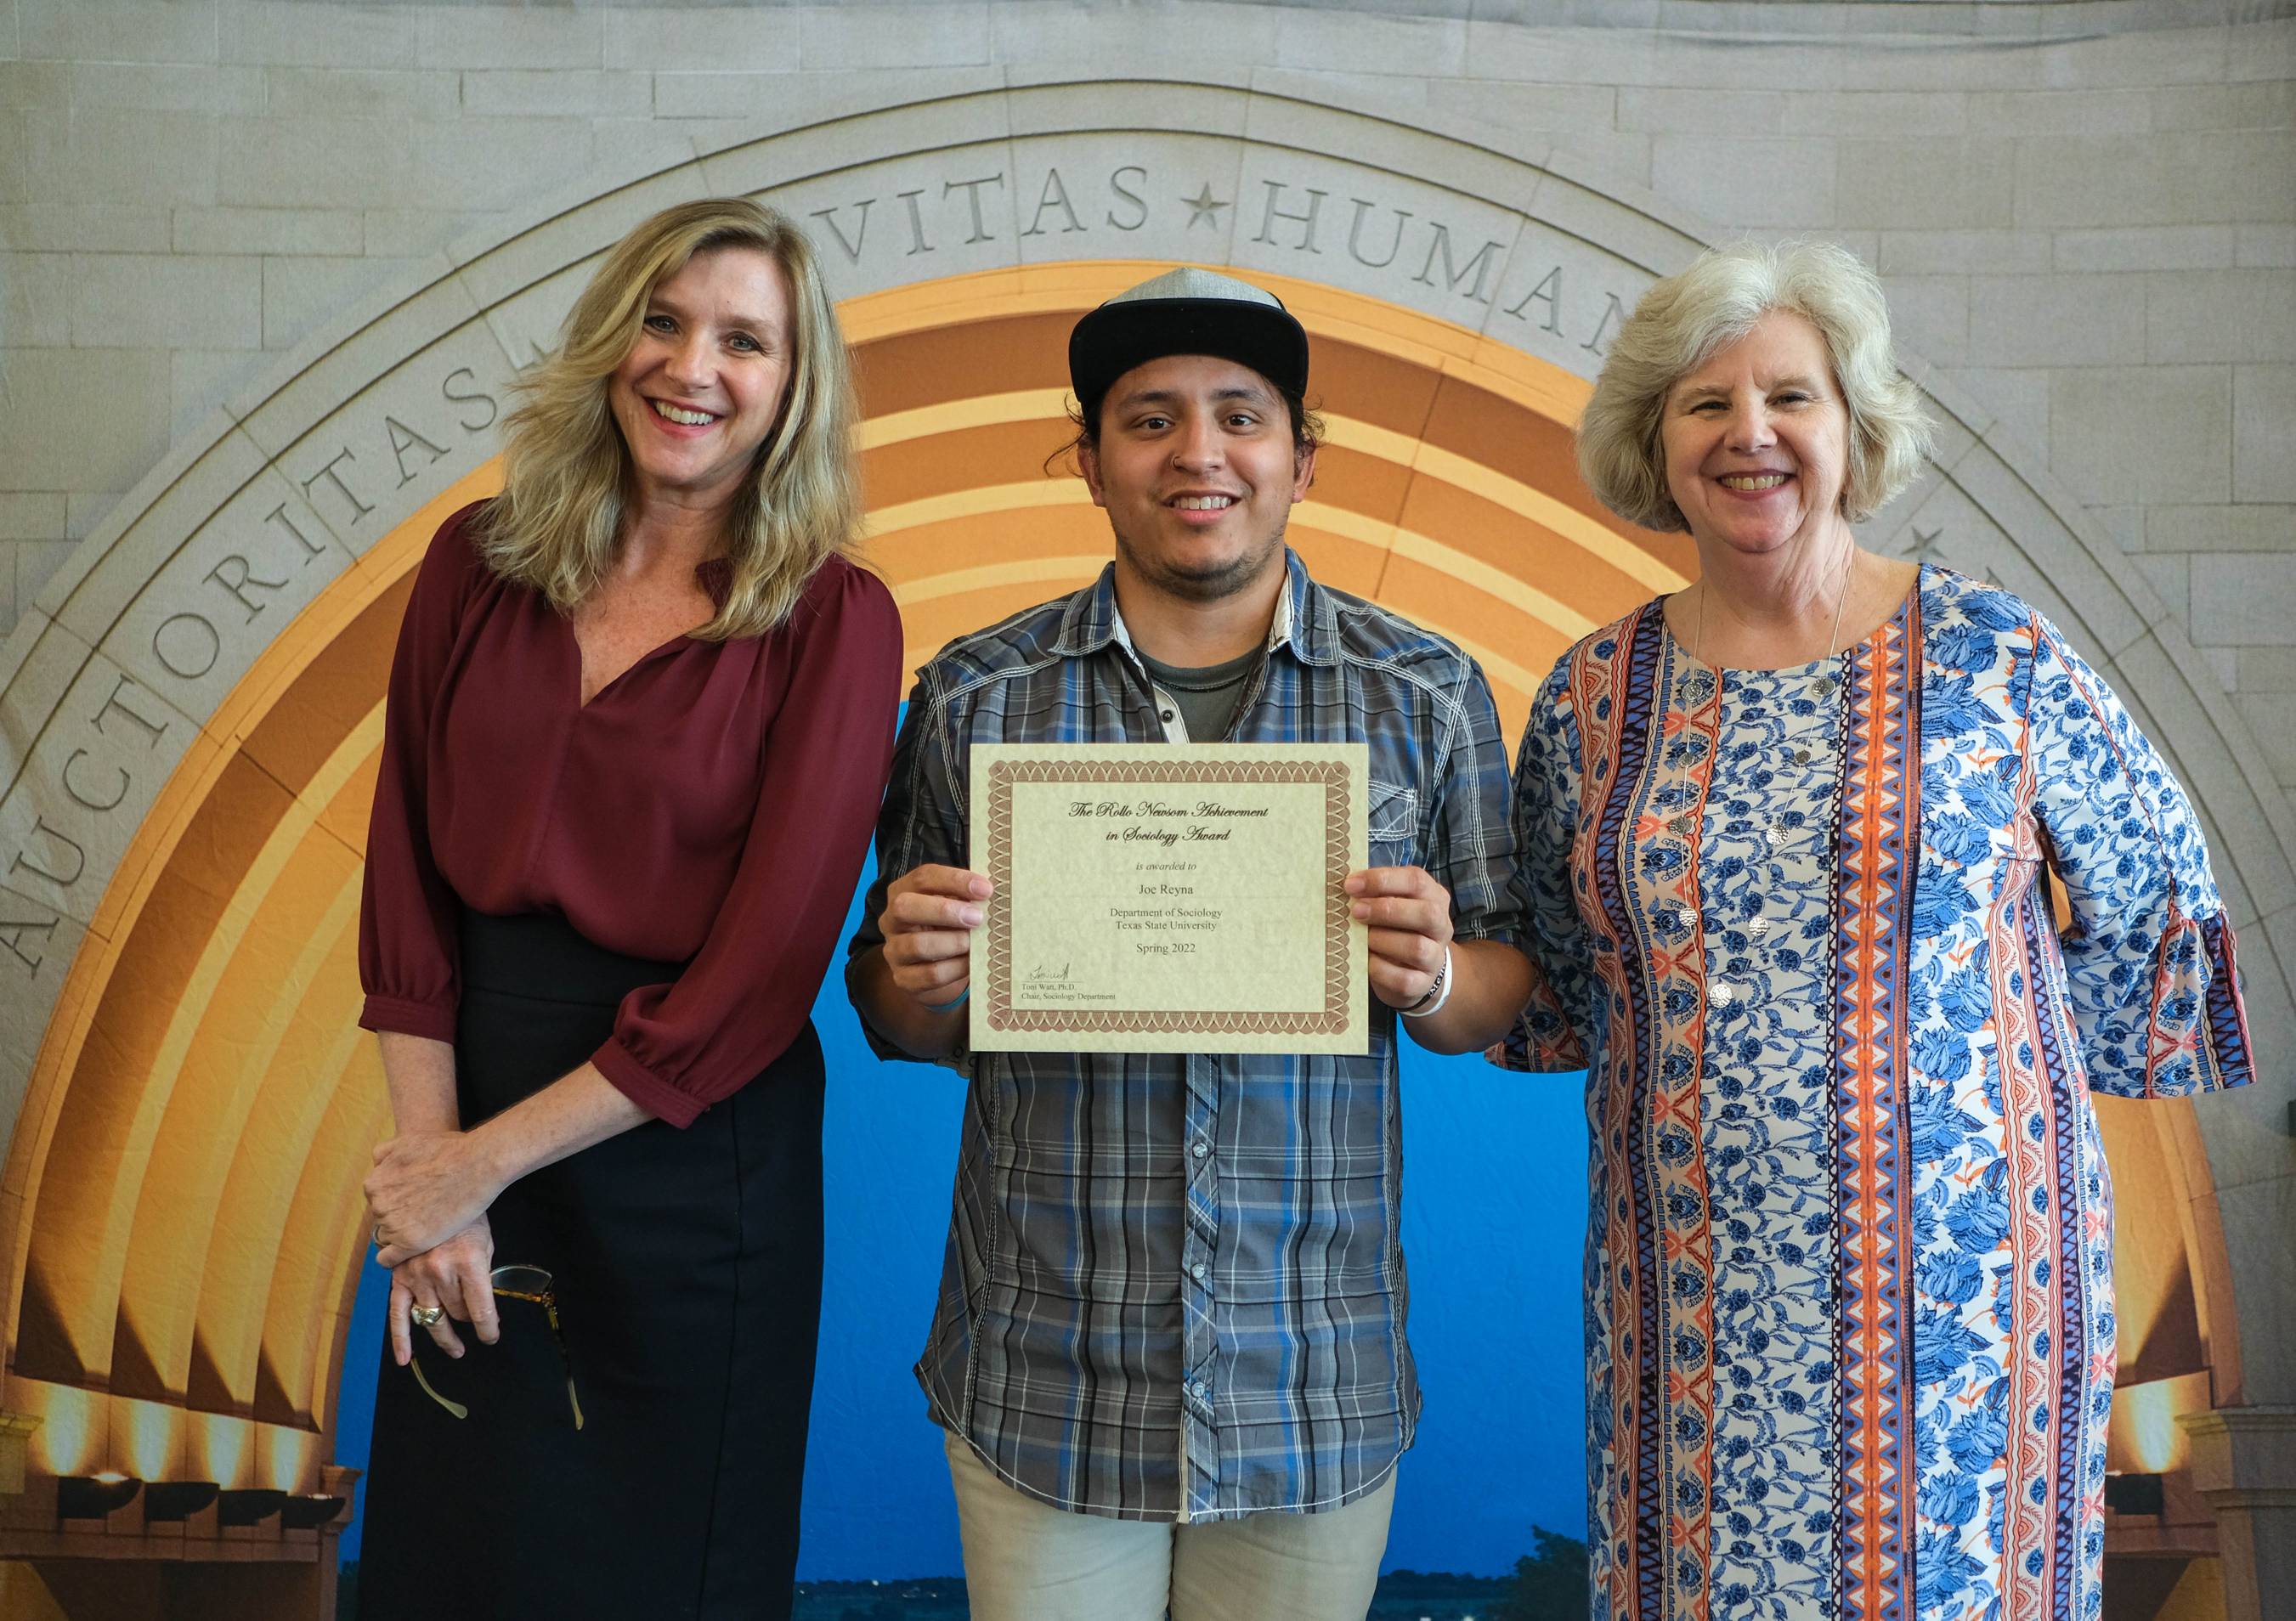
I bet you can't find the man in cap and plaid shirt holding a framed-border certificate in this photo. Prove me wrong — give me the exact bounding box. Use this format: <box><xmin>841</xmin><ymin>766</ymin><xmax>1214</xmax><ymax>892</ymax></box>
<box><xmin>847</xmin><ymin>266</ymin><xmax>1531</xmax><ymax>1579</ymax></box>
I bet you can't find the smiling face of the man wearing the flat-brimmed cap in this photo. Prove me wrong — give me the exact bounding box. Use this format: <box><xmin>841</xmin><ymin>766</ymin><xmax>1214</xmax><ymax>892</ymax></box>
<box><xmin>1079</xmin><ymin>353</ymin><xmax>1315</xmax><ymax>602</ymax></box>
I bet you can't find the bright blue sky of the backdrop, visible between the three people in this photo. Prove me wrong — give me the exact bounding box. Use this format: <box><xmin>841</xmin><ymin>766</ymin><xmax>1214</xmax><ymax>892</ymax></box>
<box><xmin>335</xmin><ymin>854</ymin><xmax>1586</xmax><ymax>1579</ymax></box>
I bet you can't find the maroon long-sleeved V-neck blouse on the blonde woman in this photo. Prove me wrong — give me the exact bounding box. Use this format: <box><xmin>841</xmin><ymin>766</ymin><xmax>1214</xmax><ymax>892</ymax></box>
<box><xmin>359</xmin><ymin>507</ymin><xmax>902</xmax><ymax>1125</ymax></box>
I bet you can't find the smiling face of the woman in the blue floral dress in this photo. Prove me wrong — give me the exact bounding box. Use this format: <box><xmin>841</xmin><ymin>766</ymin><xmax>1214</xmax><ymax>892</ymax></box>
<box><xmin>1658</xmin><ymin>310</ymin><xmax>1851</xmax><ymax>553</ymax></box>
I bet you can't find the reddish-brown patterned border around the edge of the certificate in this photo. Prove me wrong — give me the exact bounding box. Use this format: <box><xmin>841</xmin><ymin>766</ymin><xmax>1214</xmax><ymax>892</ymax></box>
<box><xmin>982</xmin><ymin>760</ymin><xmax>1357</xmax><ymax>1036</ymax></box>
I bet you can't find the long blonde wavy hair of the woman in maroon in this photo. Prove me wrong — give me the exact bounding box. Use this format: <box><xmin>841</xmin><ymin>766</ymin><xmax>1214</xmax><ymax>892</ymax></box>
<box><xmin>478</xmin><ymin>197</ymin><xmax>861</xmax><ymax>641</ymax></box>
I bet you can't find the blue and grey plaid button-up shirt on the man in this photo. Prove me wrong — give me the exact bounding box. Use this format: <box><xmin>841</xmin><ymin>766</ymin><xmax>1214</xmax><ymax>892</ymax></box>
<box><xmin>851</xmin><ymin>553</ymin><xmax>1515</xmax><ymax>1520</ymax></box>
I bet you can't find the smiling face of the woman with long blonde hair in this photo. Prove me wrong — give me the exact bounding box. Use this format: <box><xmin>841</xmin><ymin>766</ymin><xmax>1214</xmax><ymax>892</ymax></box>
<box><xmin>606</xmin><ymin>248</ymin><xmax>795</xmax><ymax>503</ymax></box>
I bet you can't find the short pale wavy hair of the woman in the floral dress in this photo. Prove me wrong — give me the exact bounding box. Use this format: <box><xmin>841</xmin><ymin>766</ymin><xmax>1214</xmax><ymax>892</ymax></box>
<box><xmin>1577</xmin><ymin>241</ymin><xmax>1931</xmax><ymax>530</ymax></box>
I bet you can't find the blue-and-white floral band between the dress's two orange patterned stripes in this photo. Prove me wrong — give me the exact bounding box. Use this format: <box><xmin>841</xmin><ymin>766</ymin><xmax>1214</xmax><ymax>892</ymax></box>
<box><xmin>1699</xmin><ymin>659</ymin><xmax>1841</xmax><ymax>1621</ymax></box>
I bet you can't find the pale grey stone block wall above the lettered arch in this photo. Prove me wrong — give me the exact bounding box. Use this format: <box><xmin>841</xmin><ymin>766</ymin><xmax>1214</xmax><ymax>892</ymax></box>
<box><xmin>0</xmin><ymin>0</ymin><xmax>2296</xmax><ymax>785</ymax></box>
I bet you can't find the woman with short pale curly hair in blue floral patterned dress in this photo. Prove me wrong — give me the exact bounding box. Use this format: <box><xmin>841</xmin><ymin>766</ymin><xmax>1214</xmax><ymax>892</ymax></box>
<box><xmin>1497</xmin><ymin>246</ymin><xmax>2248</xmax><ymax>1621</ymax></box>
